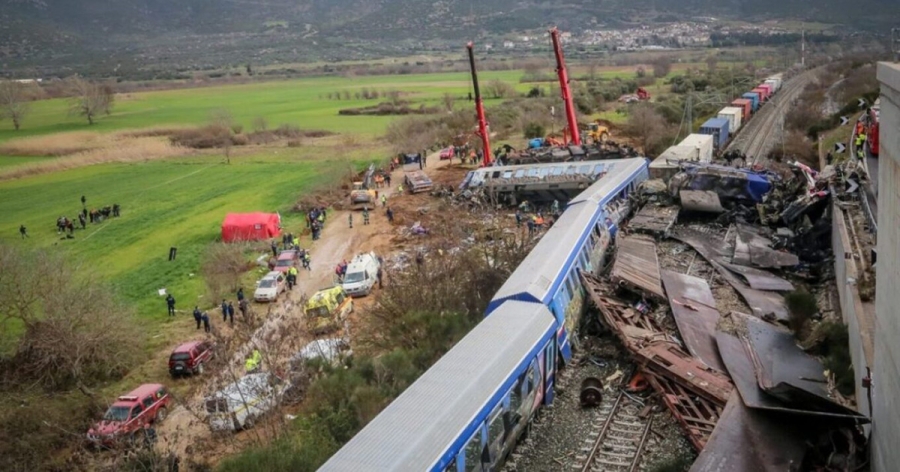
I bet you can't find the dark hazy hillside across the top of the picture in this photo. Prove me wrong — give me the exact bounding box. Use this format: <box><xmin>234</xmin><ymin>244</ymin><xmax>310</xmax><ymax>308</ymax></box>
<box><xmin>0</xmin><ymin>0</ymin><xmax>900</xmax><ymax>73</ymax></box>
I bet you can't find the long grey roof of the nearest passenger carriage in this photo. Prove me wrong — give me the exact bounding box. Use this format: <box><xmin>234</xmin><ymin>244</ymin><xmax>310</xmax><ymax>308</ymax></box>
<box><xmin>319</xmin><ymin>301</ymin><xmax>555</xmax><ymax>471</ymax></box>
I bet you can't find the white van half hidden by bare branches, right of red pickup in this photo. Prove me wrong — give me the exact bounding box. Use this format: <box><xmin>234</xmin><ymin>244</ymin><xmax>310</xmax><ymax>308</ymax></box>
<box><xmin>206</xmin><ymin>372</ymin><xmax>288</xmax><ymax>431</ymax></box>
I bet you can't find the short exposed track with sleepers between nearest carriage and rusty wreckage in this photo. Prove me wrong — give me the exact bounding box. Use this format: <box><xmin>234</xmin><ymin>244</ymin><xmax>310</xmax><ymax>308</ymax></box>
<box><xmin>572</xmin><ymin>393</ymin><xmax>652</xmax><ymax>472</ymax></box>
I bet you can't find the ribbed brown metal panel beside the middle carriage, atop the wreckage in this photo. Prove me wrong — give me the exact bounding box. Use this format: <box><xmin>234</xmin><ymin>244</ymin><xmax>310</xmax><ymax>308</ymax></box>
<box><xmin>610</xmin><ymin>235</ymin><xmax>666</xmax><ymax>300</ymax></box>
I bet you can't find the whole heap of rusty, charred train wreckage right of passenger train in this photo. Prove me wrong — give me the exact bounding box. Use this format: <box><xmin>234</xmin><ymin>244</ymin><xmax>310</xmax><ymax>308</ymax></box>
<box><xmin>581</xmin><ymin>159</ymin><xmax>869</xmax><ymax>472</ymax></box>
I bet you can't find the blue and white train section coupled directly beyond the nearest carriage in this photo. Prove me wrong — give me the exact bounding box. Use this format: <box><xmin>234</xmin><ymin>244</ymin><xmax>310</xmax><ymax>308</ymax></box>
<box><xmin>487</xmin><ymin>158</ymin><xmax>649</xmax><ymax>361</ymax></box>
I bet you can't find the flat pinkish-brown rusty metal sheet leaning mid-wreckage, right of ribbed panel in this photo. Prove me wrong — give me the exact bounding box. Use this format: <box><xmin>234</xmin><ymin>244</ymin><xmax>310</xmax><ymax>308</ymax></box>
<box><xmin>662</xmin><ymin>270</ymin><xmax>725</xmax><ymax>372</ymax></box>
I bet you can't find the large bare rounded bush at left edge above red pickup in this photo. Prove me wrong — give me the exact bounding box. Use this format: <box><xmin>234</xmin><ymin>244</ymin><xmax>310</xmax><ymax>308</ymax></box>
<box><xmin>0</xmin><ymin>246</ymin><xmax>141</xmax><ymax>396</ymax></box>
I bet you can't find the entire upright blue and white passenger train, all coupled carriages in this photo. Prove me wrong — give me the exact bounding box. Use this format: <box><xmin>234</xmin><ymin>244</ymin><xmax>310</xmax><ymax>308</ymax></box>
<box><xmin>320</xmin><ymin>158</ymin><xmax>649</xmax><ymax>472</ymax></box>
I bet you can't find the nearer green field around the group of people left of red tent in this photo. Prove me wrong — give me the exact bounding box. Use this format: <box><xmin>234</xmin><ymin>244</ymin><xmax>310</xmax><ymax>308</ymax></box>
<box><xmin>0</xmin><ymin>146</ymin><xmax>371</xmax><ymax>334</ymax></box>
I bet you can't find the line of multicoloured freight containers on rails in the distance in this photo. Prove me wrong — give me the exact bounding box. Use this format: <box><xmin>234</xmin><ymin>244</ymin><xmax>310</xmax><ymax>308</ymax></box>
<box><xmin>650</xmin><ymin>74</ymin><xmax>782</xmax><ymax>178</ymax></box>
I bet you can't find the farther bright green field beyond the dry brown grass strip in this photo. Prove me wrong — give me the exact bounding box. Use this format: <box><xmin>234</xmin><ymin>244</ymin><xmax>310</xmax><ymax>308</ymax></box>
<box><xmin>0</xmin><ymin>71</ymin><xmax>529</xmax><ymax>143</ymax></box>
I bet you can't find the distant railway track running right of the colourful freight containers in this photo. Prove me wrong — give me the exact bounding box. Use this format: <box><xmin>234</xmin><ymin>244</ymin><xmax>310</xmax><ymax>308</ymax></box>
<box><xmin>726</xmin><ymin>70</ymin><xmax>815</xmax><ymax>164</ymax></box>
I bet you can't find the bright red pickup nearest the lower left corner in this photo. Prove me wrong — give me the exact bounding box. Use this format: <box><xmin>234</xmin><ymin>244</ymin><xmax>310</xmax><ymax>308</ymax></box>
<box><xmin>87</xmin><ymin>384</ymin><xmax>171</xmax><ymax>446</ymax></box>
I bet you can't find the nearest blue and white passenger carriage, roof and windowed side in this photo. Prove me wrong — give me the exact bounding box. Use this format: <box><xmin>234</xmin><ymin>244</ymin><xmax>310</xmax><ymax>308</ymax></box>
<box><xmin>319</xmin><ymin>301</ymin><xmax>557</xmax><ymax>472</ymax></box>
